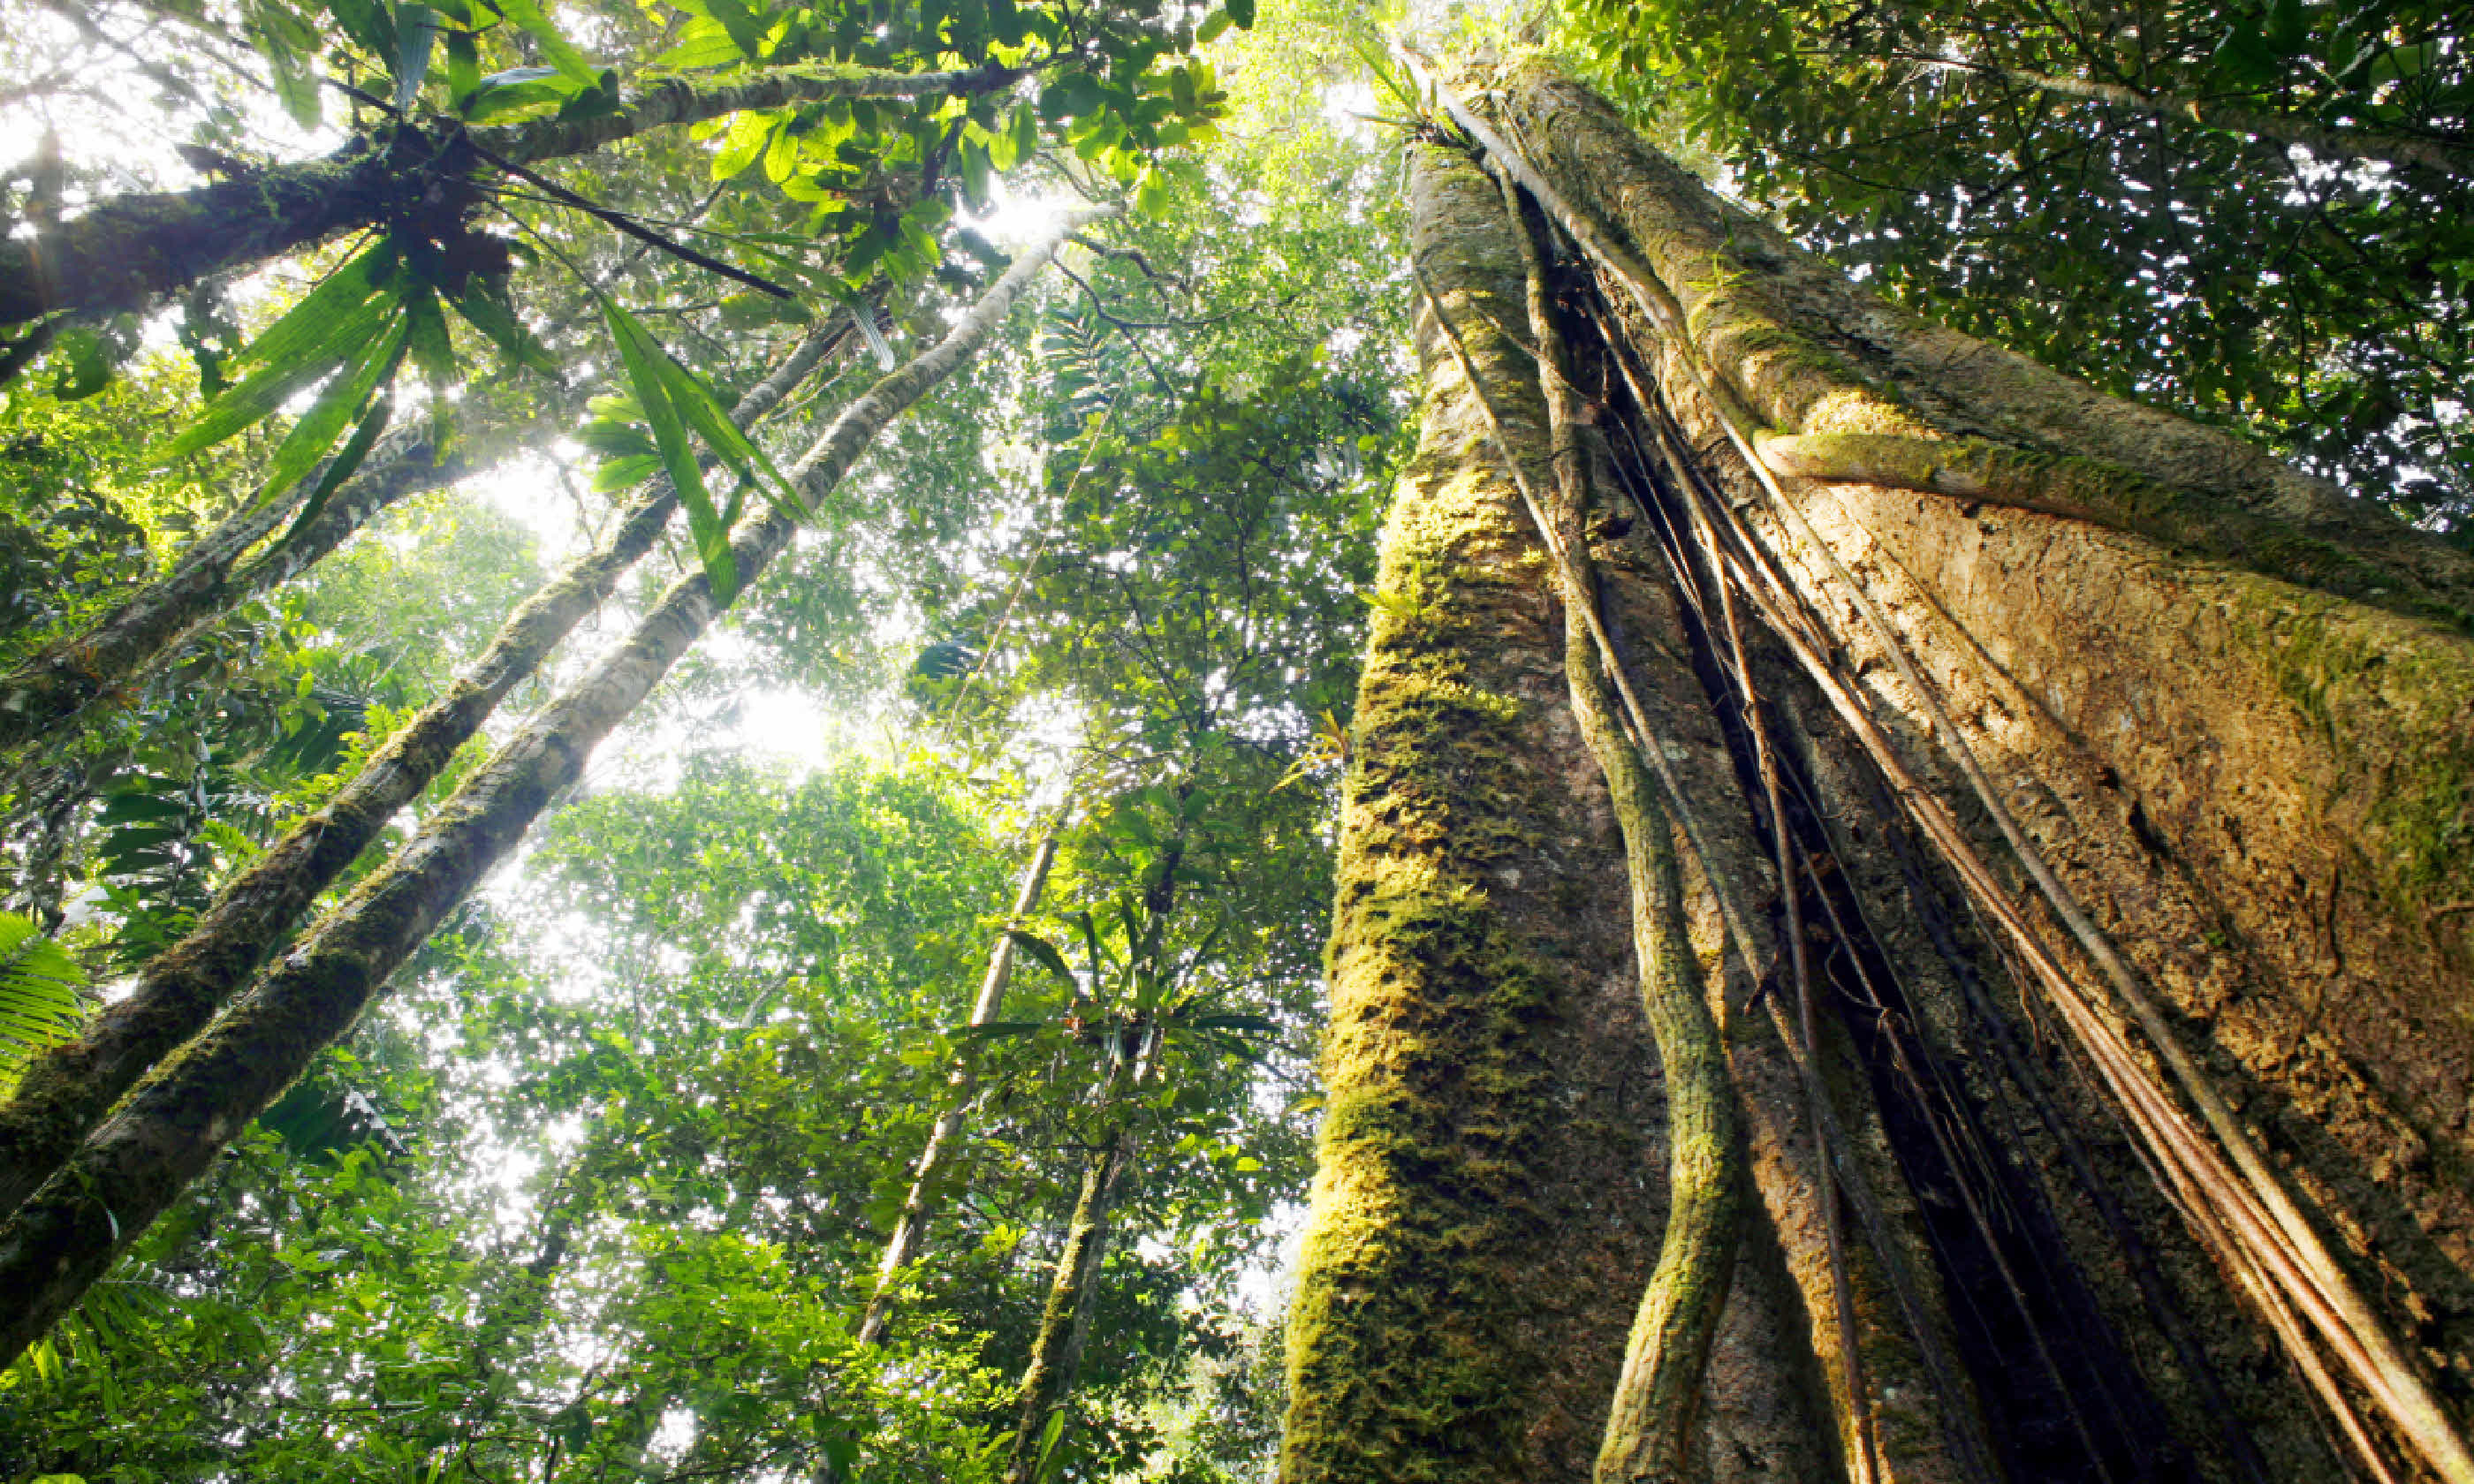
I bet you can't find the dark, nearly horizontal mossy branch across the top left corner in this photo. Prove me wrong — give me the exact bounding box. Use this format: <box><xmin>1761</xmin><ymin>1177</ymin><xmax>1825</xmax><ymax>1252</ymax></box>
<box><xmin>0</xmin><ymin>64</ymin><xmax>1020</xmax><ymax>327</ymax></box>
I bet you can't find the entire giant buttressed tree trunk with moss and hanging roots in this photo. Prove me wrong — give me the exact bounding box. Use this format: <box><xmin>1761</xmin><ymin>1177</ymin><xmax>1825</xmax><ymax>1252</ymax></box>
<box><xmin>1284</xmin><ymin>52</ymin><xmax>2474</xmax><ymax>1481</ymax></box>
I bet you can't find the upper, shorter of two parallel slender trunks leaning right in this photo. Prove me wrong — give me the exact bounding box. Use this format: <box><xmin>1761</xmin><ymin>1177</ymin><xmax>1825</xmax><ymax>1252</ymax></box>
<box><xmin>0</xmin><ymin>322</ymin><xmax>846</xmax><ymax>1212</ymax></box>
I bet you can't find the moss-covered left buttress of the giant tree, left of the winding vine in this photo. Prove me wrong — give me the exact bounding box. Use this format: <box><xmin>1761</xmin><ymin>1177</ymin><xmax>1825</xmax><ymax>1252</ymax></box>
<box><xmin>1281</xmin><ymin>144</ymin><xmax>1831</xmax><ymax>1484</ymax></box>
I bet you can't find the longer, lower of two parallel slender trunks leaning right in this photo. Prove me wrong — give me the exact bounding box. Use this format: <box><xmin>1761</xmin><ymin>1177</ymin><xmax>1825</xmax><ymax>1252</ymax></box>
<box><xmin>0</xmin><ymin>210</ymin><xmax>1108</xmax><ymax>1358</ymax></box>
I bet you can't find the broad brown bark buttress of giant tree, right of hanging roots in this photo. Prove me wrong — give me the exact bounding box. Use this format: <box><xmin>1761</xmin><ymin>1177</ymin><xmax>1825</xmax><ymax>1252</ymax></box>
<box><xmin>1506</xmin><ymin>72</ymin><xmax>2474</xmax><ymax>1444</ymax></box>
